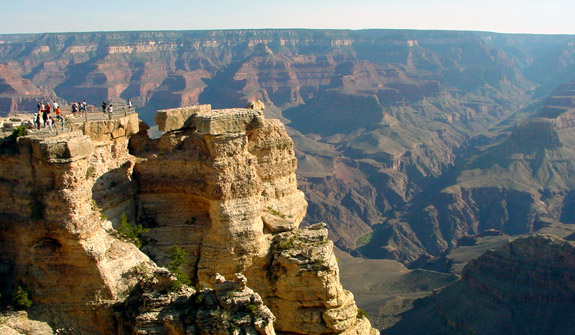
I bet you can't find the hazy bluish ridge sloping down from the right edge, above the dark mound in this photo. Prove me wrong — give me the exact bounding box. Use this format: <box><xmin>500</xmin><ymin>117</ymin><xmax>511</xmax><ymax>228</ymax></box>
<box><xmin>396</xmin><ymin>83</ymin><xmax>575</xmax><ymax>255</ymax></box>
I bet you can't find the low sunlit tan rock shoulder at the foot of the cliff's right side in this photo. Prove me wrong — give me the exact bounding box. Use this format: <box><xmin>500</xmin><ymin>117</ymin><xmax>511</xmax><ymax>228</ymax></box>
<box><xmin>264</xmin><ymin>224</ymin><xmax>377</xmax><ymax>335</ymax></box>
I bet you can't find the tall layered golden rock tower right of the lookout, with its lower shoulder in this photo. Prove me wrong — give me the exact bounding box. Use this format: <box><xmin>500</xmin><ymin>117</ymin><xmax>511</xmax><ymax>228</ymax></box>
<box><xmin>132</xmin><ymin>109</ymin><xmax>371</xmax><ymax>334</ymax></box>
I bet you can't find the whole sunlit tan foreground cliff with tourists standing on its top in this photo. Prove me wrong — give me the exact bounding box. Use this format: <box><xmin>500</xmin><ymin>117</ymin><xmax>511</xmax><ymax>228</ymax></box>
<box><xmin>0</xmin><ymin>106</ymin><xmax>378</xmax><ymax>334</ymax></box>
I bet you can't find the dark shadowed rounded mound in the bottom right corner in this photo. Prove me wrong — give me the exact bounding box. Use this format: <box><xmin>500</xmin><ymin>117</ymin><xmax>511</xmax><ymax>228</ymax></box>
<box><xmin>386</xmin><ymin>235</ymin><xmax>575</xmax><ymax>334</ymax></box>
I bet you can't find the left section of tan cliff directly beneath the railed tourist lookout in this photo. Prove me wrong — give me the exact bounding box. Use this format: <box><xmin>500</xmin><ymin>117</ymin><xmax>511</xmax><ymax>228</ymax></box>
<box><xmin>0</xmin><ymin>114</ymin><xmax>153</xmax><ymax>333</ymax></box>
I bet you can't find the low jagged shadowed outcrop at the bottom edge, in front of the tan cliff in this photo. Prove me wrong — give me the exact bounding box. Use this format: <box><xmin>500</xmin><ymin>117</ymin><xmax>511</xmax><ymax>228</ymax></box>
<box><xmin>116</xmin><ymin>269</ymin><xmax>276</xmax><ymax>335</ymax></box>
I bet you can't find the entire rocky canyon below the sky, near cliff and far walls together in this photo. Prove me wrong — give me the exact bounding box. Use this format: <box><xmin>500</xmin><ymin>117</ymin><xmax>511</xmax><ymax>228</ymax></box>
<box><xmin>4</xmin><ymin>29</ymin><xmax>575</xmax><ymax>334</ymax></box>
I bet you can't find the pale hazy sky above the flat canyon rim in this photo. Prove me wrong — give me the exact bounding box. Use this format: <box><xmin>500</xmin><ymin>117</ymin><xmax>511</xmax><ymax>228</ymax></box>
<box><xmin>0</xmin><ymin>0</ymin><xmax>575</xmax><ymax>34</ymax></box>
